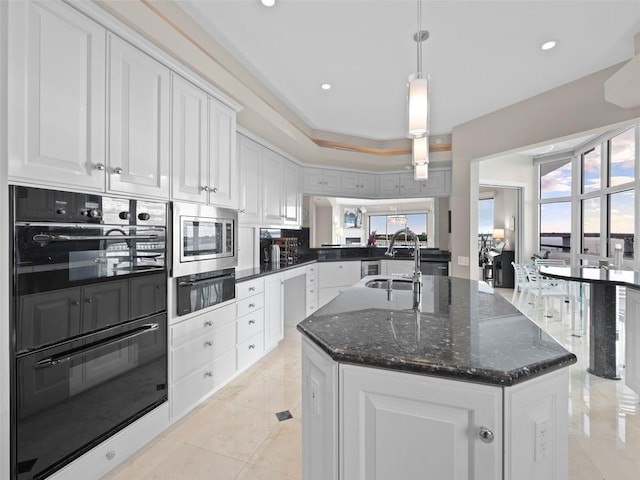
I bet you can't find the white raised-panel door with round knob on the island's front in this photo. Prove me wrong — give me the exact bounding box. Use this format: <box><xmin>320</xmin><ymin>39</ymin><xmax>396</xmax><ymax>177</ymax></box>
<box><xmin>338</xmin><ymin>365</ymin><xmax>503</xmax><ymax>480</ymax></box>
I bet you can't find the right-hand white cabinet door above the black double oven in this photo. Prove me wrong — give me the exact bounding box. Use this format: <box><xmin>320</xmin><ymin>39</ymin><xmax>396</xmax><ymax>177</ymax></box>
<box><xmin>107</xmin><ymin>35</ymin><xmax>170</xmax><ymax>199</ymax></box>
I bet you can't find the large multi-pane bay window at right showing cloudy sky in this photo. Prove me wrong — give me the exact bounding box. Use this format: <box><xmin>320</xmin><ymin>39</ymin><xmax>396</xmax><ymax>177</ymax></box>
<box><xmin>537</xmin><ymin>125</ymin><xmax>640</xmax><ymax>260</ymax></box>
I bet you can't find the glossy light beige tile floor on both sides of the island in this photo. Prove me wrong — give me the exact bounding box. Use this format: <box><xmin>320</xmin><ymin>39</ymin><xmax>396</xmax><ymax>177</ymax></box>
<box><xmin>104</xmin><ymin>289</ymin><xmax>640</xmax><ymax>480</ymax></box>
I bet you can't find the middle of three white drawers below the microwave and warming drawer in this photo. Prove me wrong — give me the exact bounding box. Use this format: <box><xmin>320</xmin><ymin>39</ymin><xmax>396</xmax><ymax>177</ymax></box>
<box><xmin>171</xmin><ymin>323</ymin><xmax>236</xmax><ymax>382</ymax></box>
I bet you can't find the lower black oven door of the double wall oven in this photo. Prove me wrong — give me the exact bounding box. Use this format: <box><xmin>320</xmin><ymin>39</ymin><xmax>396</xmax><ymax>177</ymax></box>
<box><xmin>15</xmin><ymin>313</ymin><xmax>167</xmax><ymax>479</ymax></box>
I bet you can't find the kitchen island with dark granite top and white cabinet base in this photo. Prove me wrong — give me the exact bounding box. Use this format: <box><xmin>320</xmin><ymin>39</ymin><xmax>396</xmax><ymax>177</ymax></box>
<box><xmin>298</xmin><ymin>276</ymin><xmax>576</xmax><ymax>480</ymax></box>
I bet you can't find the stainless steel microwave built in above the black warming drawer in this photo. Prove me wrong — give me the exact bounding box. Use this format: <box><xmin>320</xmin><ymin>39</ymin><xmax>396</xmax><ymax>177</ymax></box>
<box><xmin>171</xmin><ymin>202</ymin><xmax>238</xmax><ymax>277</ymax></box>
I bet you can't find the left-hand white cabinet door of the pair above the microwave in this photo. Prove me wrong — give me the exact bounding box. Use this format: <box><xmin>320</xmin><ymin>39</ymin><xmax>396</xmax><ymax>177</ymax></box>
<box><xmin>171</xmin><ymin>75</ymin><xmax>209</xmax><ymax>203</ymax></box>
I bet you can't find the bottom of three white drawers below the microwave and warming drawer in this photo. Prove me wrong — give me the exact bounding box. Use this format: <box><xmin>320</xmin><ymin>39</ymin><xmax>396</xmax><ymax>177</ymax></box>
<box><xmin>169</xmin><ymin>349</ymin><xmax>236</xmax><ymax>417</ymax></box>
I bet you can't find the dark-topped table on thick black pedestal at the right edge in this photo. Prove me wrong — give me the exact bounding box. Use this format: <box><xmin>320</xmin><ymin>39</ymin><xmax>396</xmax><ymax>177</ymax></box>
<box><xmin>539</xmin><ymin>265</ymin><xmax>640</xmax><ymax>380</ymax></box>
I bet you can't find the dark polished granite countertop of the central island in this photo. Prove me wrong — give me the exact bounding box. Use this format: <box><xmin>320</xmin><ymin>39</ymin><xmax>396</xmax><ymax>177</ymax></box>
<box><xmin>297</xmin><ymin>275</ymin><xmax>576</xmax><ymax>386</ymax></box>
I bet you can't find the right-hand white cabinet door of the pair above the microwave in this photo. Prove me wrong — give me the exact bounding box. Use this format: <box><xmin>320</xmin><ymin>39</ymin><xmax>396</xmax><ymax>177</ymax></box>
<box><xmin>209</xmin><ymin>97</ymin><xmax>238</xmax><ymax>208</ymax></box>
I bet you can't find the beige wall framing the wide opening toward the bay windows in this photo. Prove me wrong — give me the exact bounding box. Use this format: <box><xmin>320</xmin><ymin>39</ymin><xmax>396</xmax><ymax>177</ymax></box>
<box><xmin>450</xmin><ymin>65</ymin><xmax>640</xmax><ymax>278</ymax></box>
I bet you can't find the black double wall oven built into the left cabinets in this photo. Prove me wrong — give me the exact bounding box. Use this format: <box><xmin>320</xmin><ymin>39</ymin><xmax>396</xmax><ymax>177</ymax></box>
<box><xmin>11</xmin><ymin>186</ymin><xmax>167</xmax><ymax>480</ymax></box>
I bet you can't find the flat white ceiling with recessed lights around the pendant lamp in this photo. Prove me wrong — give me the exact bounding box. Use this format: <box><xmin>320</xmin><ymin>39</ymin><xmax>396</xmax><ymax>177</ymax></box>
<box><xmin>176</xmin><ymin>0</ymin><xmax>640</xmax><ymax>145</ymax></box>
